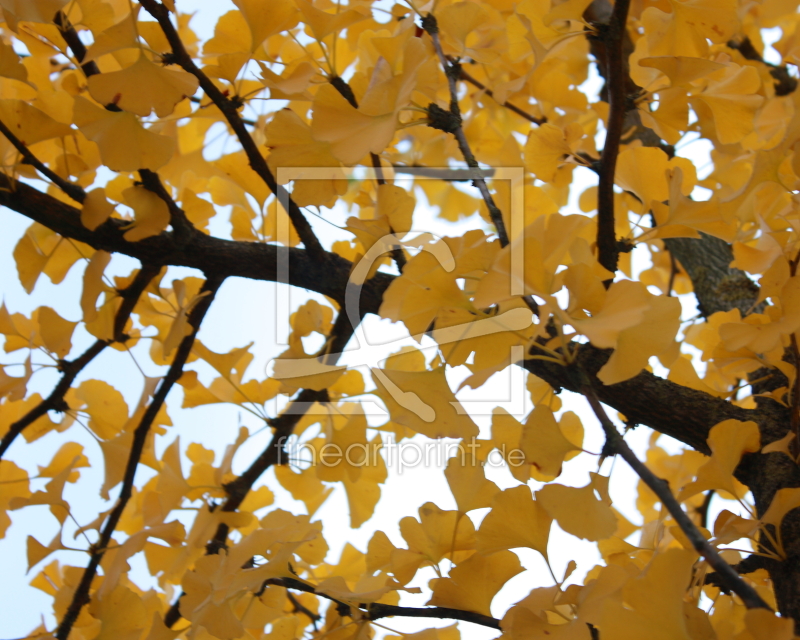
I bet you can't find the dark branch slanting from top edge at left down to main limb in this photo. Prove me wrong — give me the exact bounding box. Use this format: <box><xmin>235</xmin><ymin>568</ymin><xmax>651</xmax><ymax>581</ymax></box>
<box><xmin>141</xmin><ymin>0</ymin><xmax>328</xmax><ymax>262</ymax></box>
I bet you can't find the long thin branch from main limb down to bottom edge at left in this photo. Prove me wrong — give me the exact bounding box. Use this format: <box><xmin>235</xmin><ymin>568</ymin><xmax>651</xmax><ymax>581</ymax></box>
<box><xmin>55</xmin><ymin>276</ymin><xmax>224</xmax><ymax>640</ymax></box>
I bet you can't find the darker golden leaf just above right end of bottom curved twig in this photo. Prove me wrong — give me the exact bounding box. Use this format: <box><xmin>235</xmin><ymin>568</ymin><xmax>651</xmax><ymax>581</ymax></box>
<box><xmin>428</xmin><ymin>551</ymin><xmax>523</xmax><ymax>616</ymax></box>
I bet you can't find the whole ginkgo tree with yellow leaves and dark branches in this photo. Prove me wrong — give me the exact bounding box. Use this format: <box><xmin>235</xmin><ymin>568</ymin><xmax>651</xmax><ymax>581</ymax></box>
<box><xmin>0</xmin><ymin>0</ymin><xmax>800</xmax><ymax>640</ymax></box>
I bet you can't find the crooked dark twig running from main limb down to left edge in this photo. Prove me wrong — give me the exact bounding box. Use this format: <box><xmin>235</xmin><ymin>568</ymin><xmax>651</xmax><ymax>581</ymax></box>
<box><xmin>0</xmin><ymin>265</ymin><xmax>160</xmax><ymax>459</ymax></box>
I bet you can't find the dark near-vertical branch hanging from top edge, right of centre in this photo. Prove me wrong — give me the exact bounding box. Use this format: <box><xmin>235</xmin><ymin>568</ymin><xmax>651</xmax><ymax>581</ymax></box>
<box><xmin>597</xmin><ymin>0</ymin><xmax>630</xmax><ymax>285</ymax></box>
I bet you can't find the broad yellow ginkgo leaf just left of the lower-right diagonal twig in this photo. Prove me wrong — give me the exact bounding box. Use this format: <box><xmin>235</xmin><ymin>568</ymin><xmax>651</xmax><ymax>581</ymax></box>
<box><xmin>536</xmin><ymin>482</ymin><xmax>617</xmax><ymax>541</ymax></box>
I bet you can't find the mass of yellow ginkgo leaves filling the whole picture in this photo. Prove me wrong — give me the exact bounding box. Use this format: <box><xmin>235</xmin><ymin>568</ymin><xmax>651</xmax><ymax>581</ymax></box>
<box><xmin>0</xmin><ymin>0</ymin><xmax>800</xmax><ymax>640</ymax></box>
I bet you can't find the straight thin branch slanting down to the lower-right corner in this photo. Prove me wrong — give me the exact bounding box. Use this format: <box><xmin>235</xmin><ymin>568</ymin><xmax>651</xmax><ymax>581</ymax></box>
<box><xmin>580</xmin><ymin>371</ymin><xmax>772</xmax><ymax>611</ymax></box>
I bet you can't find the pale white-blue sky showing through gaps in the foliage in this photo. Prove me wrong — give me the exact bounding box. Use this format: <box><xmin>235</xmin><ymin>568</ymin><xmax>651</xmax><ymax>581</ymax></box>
<box><xmin>0</xmin><ymin>0</ymin><xmax>780</xmax><ymax>640</ymax></box>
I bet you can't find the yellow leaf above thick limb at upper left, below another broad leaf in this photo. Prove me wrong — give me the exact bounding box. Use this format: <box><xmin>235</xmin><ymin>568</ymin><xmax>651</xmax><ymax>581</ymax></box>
<box><xmin>74</xmin><ymin>96</ymin><xmax>176</xmax><ymax>171</ymax></box>
